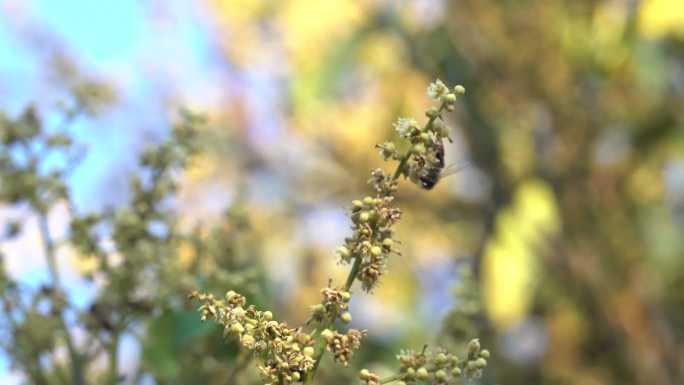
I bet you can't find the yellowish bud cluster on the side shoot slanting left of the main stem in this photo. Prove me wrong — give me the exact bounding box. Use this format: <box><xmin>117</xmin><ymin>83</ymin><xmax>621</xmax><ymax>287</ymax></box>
<box><xmin>190</xmin><ymin>291</ymin><xmax>315</xmax><ymax>384</ymax></box>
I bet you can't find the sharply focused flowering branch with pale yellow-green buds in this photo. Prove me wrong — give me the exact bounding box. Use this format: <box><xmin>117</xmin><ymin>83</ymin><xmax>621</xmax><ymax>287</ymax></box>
<box><xmin>191</xmin><ymin>80</ymin><xmax>489</xmax><ymax>385</ymax></box>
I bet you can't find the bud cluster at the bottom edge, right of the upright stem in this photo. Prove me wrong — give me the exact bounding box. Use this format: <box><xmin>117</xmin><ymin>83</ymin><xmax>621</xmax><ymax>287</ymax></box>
<box><xmin>388</xmin><ymin>339</ymin><xmax>489</xmax><ymax>385</ymax></box>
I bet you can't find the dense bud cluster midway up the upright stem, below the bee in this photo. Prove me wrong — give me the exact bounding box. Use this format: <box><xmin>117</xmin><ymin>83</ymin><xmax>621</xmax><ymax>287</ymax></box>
<box><xmin>337</xmin><ymin>170</ymin><xmax>401</xmax><ymax>291</ymax></box>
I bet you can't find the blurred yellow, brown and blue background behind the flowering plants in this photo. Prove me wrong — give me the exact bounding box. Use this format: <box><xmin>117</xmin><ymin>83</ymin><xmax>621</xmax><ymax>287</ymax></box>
<box><xmin>0</xmin><ymin>0</ymin><xmax>684</xmax><ymax>385</ymax></box>
